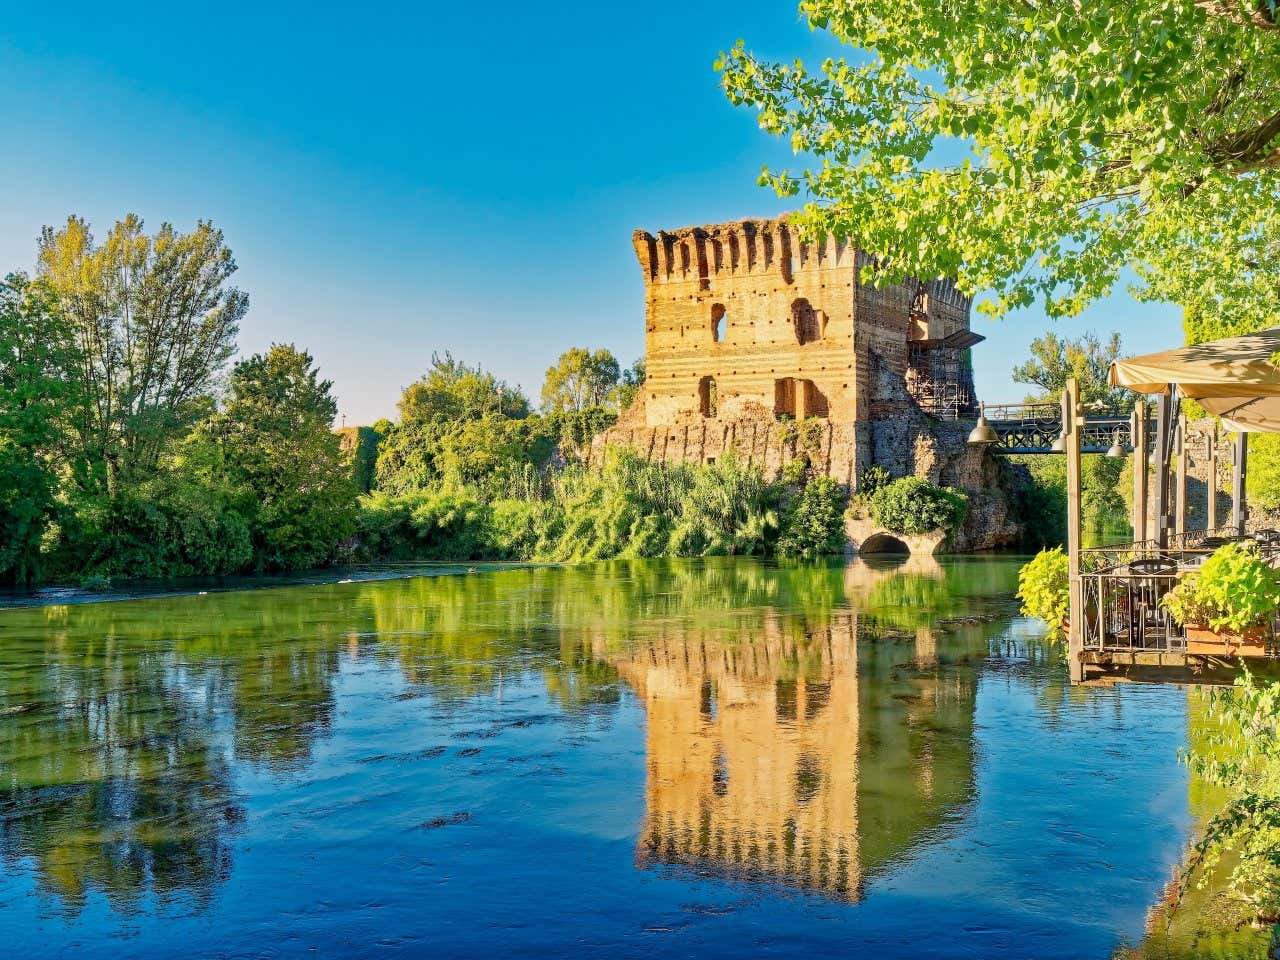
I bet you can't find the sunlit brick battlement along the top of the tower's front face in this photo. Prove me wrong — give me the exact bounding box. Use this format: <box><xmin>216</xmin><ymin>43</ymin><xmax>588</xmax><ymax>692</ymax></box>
<box><xmin>631</xmin><ymin>218</ymin><xmax>863</xmax><ymax>288</ymax></box>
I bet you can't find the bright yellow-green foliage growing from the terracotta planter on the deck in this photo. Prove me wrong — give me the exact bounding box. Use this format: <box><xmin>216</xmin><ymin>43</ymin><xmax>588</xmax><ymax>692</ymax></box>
<box><xmin>1162</xmin><ymin>543</ymin><xmax>1280</xmax><ymax>634</ymax></box>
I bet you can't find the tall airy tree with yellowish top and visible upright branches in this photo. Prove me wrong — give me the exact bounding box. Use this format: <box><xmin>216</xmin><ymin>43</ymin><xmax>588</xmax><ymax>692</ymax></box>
<box><xmin>40</xmin><ymin>214</ymin><xmax>248</xmax><ymax>494</ymax></box>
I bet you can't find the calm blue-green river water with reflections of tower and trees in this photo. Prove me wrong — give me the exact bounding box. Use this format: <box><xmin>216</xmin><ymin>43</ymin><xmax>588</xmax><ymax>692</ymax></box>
<box><xmin>0</xmin><ymin>557</ymin><xmax>1239</xmax><ymax>959</ymax></box>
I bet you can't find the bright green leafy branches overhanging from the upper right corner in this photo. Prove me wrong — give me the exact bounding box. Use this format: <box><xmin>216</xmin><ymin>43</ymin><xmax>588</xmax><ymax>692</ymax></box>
<box><xmin>718</xmin><ymin>0</ymin><xmax>1280</xmax><ymax>323</ymax></box>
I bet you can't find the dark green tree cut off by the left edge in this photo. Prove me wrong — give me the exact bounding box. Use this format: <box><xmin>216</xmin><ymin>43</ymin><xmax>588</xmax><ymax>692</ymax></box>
<box><xmin>0</xmin><ymin>274</ymin><xmax>76</xmax><ymax>584</ymax></box>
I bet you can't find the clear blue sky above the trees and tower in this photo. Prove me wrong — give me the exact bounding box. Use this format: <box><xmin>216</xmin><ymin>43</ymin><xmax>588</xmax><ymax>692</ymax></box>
<box><xmin>0</xmin><ymin>0</ymin><xmax>1181</xmax><ymax>422</ymax></box>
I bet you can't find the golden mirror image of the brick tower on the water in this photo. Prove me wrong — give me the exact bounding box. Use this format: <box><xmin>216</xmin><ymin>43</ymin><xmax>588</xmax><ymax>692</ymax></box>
<box><xmin>603</xmin><ymin>561</ymin><xmax>987</xmax><ymax>901</ymax></box>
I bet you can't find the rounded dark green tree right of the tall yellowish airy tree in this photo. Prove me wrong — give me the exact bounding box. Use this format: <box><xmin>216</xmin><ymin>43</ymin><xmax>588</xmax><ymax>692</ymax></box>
<box><xmin>204</xmin><ymin>344</ymin><xmax>356</xmax><ymax>570</ymax></box>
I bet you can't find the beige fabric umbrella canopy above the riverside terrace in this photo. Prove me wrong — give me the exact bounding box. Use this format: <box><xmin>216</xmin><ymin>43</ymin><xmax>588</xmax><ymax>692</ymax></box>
<box><xmin>1110</xmin><ymin>326</ymin><xmax>1280</xmax><ymax>433</ymax></box>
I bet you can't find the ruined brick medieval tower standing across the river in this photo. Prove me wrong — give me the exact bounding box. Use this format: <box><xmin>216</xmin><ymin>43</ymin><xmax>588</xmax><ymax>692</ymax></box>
<box><xmin>595</xmin><ymin>218</ymin><xmax>1018</xmax><ymax>549</ymax></box>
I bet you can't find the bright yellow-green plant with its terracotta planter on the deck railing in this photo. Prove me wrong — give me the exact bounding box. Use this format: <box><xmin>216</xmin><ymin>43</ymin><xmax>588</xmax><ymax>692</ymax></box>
<box><xmin>1161</xmin><ymin>543</ymin><xmax>1280</xmax><ymax>655</ymax></box>
